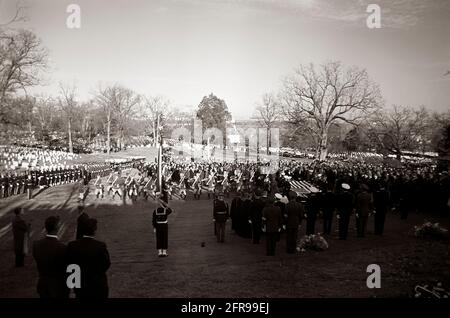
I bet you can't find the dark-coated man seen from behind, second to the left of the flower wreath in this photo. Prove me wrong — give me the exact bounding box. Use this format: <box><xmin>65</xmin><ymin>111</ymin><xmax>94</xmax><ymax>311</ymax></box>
<box><xmin>262</xmin><ymin>198</ymin><xmax>283</xmax><ymax>256</ymax></box>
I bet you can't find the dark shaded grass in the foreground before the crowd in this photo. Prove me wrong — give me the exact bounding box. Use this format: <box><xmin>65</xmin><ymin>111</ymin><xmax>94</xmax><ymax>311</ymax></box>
<box><xmin>0</xmin><ymin>179</ymin><xmax>450</xmax><ymax>298</ymax></box>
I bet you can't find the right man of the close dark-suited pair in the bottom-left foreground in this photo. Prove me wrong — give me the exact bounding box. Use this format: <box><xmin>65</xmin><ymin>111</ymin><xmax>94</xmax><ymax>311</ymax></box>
<box><xmin>67</xmin><ymin>219</ymin><xmax>111</xmax><ymax>299</ymax></box>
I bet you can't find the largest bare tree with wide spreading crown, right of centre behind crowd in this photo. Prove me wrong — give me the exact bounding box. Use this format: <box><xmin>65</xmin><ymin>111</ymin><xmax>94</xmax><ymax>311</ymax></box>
<box><xmin>282</xmin><ymin>62</ymin><xmax>381</xmax><ymax>160</ymax></box>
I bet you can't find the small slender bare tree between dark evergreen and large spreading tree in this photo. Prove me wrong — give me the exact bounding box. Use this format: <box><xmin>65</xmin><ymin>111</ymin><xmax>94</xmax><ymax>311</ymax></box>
<box><xmin>256</xmin><ymin>94</ymin><xmax>282</xmax><ymax>154</ymax></box>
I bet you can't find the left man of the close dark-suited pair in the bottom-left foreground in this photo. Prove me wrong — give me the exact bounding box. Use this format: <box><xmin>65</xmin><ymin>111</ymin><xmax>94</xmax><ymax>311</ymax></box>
<box><xmin>33</xmin><ymin>216</ymin><xmax>70</xmax><ymax>298</ymax></box>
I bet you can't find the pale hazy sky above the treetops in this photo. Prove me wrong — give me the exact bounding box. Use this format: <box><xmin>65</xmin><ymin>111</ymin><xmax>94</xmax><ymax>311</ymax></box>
<box><xmin>0</xmin><ymin>0</ymin><xmax>450</xmax><ymax>118</ymax></box>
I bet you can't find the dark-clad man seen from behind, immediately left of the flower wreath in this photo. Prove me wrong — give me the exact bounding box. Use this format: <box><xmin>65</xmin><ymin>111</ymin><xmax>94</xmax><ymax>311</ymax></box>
<box><xmin>284</xmin><ymin>192</ymin><xmax>305</xmax><ymax>254</ymax></box>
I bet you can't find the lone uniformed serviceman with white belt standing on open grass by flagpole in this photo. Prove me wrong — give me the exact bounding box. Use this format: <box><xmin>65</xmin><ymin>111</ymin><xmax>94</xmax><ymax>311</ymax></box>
<box><xmin>152</xmin><ymin>200</ymin><xmax>172</xmax><ymax>257</ymax></box>
